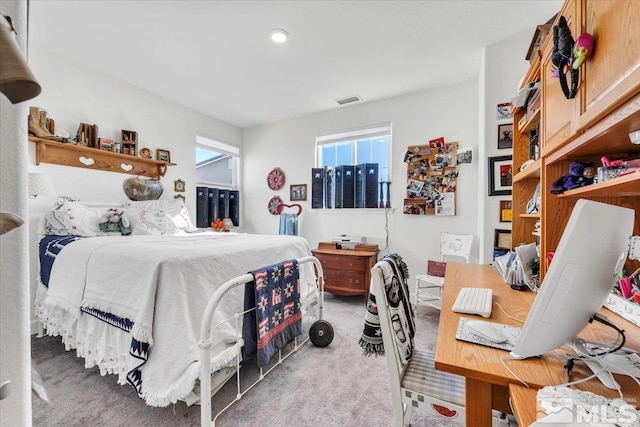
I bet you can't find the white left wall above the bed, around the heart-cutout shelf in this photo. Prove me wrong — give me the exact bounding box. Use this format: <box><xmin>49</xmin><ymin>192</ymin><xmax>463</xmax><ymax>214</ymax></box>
<box><xmin>24</xmin><ymin>49</ymin><xmax>242</xmax><ymax>330</ymax></box>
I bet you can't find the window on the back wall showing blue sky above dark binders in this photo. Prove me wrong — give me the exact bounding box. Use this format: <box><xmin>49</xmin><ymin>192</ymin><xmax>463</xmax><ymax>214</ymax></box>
<box><xmin>316</xmin><ymin>123</ymin><xmax>391</xmax><ymax>181</ymax></box>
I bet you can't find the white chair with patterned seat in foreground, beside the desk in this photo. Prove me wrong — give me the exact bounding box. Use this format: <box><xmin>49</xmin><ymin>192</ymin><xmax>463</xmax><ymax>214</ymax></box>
<box><xmin>371</xmin><ymin>257</ymin><xmax>465</xmax><ymax>427</ymax></box>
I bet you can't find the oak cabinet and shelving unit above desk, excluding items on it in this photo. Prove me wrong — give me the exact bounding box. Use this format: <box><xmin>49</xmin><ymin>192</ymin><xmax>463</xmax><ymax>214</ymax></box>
<box><xmin>512</xmin><ymin>0</ymin><xmax>640</xmax><ymax>276</ymax></box>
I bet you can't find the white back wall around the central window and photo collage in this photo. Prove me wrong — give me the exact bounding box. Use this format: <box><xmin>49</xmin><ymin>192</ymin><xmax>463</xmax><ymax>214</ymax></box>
<box><xmin>242</xmin><ymin>82</ymin><xmax>482</xmax><ymax>275</ymax></box>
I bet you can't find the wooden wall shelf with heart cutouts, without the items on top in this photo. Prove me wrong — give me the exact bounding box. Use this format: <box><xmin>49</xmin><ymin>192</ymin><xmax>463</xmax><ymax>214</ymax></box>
<box><xmin>29</xmin><ymin>136</ymin><xmax>175</xmax><ymax>178</ymax></box>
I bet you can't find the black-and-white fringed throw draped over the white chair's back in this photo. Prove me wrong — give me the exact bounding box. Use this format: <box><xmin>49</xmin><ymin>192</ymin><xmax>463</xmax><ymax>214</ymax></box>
<box><xmin>360</xmin><ymin>254</ymin><xmax>415</xmax><ymax>363</ymax></box>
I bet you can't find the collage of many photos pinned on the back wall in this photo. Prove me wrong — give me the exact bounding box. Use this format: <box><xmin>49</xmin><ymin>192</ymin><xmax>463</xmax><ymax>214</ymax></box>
<box><xmin>404</xmin><ymin>138</ymin><xmax>458</xmax><ymax>216</ymax></box>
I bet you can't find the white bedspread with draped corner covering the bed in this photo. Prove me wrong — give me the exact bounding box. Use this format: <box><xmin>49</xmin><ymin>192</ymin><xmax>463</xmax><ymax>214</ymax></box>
<box><xmin>41</xmin><ymin>233</ymin><xmax>314</xmax><ymax>406</ymax></box>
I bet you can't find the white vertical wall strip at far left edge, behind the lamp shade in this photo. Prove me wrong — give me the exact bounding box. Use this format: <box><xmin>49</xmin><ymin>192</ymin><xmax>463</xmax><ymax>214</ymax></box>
<box><xmin>0</xmin><ymin>0</ymin><xmax>31</xmax><ymax>427</ymax></box>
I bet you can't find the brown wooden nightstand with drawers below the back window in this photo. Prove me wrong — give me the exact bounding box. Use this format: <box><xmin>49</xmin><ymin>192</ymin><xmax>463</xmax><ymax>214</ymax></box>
<box><xmin>311</xmin><ymin>242</ymin><xmax>378</xmax><ymax>297</ymax></box>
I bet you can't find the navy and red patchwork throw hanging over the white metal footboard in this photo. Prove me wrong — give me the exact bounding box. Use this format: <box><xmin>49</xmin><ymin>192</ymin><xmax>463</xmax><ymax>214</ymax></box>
<box><xmin>242</xmin><ymin>259</ymin><xmax>302</xmax><ymax>367</ymax></box>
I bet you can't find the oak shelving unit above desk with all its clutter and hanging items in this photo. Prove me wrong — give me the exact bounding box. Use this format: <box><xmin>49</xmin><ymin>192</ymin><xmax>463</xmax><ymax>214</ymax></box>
<box><xmin>512</xmin><ymin>0</ymin><xmax>640</xmax><ymax>286</ymax></box>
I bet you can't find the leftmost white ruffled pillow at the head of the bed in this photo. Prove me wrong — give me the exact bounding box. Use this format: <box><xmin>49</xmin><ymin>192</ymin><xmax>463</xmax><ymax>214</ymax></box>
<box><xmin>46</xmin><ymin>202</ymin><xmax>109</xmax><ymax>237</ymax></box>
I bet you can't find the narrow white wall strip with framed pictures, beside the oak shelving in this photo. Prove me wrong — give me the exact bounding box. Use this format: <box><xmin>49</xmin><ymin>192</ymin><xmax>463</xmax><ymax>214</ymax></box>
<box><xmin>479</xmin><ymin>30</ymin><xmax>533</xmax><ymax>263</ymax></box>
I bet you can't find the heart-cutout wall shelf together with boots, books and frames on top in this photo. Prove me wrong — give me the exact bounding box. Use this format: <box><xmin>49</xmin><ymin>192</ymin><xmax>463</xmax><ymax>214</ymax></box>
<box><xmin>28</xmin><ymin>107</ymin><xmax>175</xmax><ymax>178</ymax></box>
